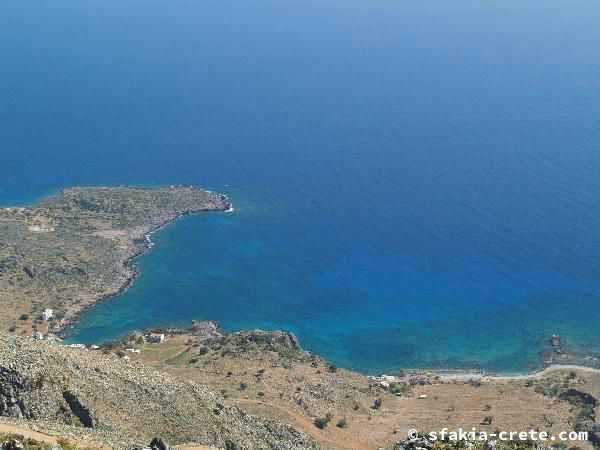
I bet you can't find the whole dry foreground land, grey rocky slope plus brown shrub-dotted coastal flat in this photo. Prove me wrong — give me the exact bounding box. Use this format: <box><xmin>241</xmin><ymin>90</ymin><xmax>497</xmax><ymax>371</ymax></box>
<box><xmin>0</xmin><ymin>323</ymin><xmax>600</xmax><ymax>449</ymax></box>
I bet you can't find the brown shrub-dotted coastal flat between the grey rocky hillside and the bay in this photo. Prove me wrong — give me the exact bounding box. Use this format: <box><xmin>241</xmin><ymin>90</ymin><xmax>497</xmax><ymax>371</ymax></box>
<box><xmin>125</xmin><ymin>324</ymin><xmax>600</xmax><ymax>449</ymax></box>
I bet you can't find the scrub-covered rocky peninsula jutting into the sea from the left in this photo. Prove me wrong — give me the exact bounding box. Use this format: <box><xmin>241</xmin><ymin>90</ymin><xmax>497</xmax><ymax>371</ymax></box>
<box><xmin>0</xmin><ymin>186</ymin><xmax>230</xmax><ymax>335</ymax></box>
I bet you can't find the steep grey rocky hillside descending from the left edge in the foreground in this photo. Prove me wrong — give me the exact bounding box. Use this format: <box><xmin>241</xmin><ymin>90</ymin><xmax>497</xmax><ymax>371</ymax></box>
<box><xmin>0</xmin><ymin>334</ymin><xmax>320</xmax><ymax>449</ymax></box>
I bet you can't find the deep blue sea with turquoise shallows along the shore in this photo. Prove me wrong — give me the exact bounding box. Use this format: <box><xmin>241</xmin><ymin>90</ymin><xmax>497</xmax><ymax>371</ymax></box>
<box><xmin>0</xmin><ymin>0</ymin><xmax>600</xmax><ymax>373</ymax></box>
